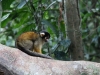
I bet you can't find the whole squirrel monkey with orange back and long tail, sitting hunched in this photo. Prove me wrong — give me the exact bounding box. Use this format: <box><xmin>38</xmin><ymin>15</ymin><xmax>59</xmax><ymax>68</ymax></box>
<box><xmin>15</xmin><ymin>31</ymin><xmax>52</xmax><ymax>59</ymax></box>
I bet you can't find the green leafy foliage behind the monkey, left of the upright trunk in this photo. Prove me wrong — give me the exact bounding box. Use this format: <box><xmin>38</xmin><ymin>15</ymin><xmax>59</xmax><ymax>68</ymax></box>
<box><xmin>0</xmin><ymin>0</ymin><xmax>70</xmax><ymax>60</ymax></box>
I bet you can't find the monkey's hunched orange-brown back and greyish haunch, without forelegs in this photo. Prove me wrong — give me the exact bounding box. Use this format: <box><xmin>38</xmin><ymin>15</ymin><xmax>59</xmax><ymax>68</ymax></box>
<box><xmin>15</xmin><ymin>32</ymin><xmax>39</xmax><ymax>50</ymax></box>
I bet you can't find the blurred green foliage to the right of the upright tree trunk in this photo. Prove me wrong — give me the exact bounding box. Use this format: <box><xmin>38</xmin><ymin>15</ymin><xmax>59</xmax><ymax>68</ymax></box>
<box><xmin>80</xmin><ymin>0</ymin><xmax>100</xmax><ymax>62</ymax></box>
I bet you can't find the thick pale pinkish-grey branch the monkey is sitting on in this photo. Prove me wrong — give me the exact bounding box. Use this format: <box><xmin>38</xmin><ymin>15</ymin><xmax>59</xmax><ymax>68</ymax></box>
<box><xmin>0</xmin><ymin>44</ymin><xmax>100</xmax><ymax>75</ymax></box>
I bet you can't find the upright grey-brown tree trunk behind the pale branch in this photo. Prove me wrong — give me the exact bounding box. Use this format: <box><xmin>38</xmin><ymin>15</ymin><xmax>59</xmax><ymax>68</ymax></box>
<box><xmin>66</xmin><ymin>0</ymin><xmax>84</xmax><ymax>60</ymax></box>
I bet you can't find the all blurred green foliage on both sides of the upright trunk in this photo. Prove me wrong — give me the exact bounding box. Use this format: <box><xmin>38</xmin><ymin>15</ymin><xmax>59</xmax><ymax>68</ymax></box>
<box><xmin>0</xmin><ymin>0</ymin><xmax>100</xmax><ymax>62</ymax></box>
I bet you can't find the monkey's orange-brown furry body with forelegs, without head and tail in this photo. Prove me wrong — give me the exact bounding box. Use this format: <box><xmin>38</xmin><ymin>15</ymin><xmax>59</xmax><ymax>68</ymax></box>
<box><xmin>16</xmin><ymin>32</ymin><xmax>44</xmax><ymax>53</ymax></box>
